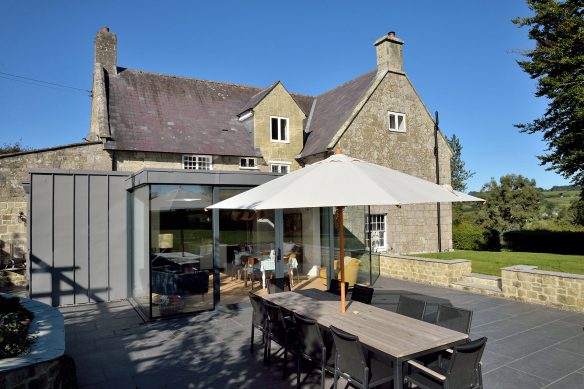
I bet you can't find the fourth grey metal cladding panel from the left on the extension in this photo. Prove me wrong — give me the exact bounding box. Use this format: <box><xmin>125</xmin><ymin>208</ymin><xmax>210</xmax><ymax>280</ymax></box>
<box><xmin>89</xmin><ymin>176</ymin><xmax>109</xmax><ymax>302</ymax></box>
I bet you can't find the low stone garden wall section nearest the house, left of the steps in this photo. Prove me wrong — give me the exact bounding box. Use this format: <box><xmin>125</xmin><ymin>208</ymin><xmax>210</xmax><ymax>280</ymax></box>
<box><xmin>379</xmin><ymin>254</ymin><xmax>471</xmax><ymax>286</ymax></box>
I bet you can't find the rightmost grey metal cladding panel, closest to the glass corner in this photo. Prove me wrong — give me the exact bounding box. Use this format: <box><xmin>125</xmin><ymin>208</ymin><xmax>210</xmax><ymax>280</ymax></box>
<box><xmin>109</xmin><ymin>176</ymin><xmax>129</xmax><ymax>300</ymax></box>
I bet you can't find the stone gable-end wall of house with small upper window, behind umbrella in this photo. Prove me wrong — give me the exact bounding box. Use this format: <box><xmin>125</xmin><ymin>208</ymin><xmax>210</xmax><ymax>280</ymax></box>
<box><xmin>338</xmin><ymin>72</ymin><xmax>452</xmax><ymax>254</ymax></box>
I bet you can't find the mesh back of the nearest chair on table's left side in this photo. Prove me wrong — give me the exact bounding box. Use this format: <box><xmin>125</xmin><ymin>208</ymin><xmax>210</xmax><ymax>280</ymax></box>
<box><xmin>331</xmin><ymin>326</ymin><xmax>367</xmax><ymax>384</ymax></box>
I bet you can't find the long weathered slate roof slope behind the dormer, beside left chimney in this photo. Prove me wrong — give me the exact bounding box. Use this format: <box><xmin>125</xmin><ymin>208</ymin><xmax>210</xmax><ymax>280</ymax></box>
<box><xmin>105</xmin><ymin>68</ymin><xmax>314</xmax><ymax>156</ymax></box>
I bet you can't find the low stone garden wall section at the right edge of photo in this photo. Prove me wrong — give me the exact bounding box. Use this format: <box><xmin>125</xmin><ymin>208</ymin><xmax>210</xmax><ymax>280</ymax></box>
<box><xmin>501</xmin><ymin>266</ymin><xmax>584</xmax><ymax>311</ymax></box>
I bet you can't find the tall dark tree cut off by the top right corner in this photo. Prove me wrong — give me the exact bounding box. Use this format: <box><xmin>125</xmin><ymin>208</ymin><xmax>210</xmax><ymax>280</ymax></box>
<box><xmin>513</xmin><ymin>0</ymin><xmax>584</xmax><ymax>198</ymax></box>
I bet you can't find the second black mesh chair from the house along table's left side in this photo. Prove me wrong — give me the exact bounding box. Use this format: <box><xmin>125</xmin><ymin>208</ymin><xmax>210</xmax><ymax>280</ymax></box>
<box><xmin>264</xmin><ymin>300</ymin><xmax>298</xmax><ymax>378</ymax></box>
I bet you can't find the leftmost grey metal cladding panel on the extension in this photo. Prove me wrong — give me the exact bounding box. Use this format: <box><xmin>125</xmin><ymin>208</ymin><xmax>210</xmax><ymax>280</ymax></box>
<box><xmin>30</xmin><ymin>174</ymin><xmax>53</xmax><ymax>304</ymax></box>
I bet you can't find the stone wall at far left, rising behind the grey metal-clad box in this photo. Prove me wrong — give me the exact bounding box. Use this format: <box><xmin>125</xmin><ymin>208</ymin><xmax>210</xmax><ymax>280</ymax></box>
<box><xmin>0</xmin><ymin>143</ymin><xmax>112</xmax><ymax>258</ymax></box>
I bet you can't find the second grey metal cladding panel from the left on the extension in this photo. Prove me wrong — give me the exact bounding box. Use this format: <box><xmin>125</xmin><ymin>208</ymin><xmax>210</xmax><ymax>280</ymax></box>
<box><xmin>52</xmin><ymin>175</ymin><xmax>75</xmax><ymax>306</ymax></box>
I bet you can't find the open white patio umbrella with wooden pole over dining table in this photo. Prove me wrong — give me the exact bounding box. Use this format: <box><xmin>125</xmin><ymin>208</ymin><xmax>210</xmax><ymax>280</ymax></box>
<box><xmin>208</xmin><ymin>151</ymin><xmax>484</xmax><ymax>312</ymax></box>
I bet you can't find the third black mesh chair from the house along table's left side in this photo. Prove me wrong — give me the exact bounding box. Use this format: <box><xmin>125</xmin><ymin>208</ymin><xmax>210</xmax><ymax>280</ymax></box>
<box><xmin>294</xmin><ymin>313</ymin><xmax>335</xmax><ymax>388</ymax></box>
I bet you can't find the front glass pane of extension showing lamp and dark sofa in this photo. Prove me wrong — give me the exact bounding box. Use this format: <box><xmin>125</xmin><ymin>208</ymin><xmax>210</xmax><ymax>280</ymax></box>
<box><xmin>150</xmin><ymin>185</ymin><xmax>213</xmax><ymax>317</ymax></box>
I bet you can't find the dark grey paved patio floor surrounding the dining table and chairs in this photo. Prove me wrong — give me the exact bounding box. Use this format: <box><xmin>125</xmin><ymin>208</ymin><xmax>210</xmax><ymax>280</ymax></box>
<box><xmin>61</xmin><ymin>277</ymin><xmax>584</xmax><ymax>389</ymax></box>
